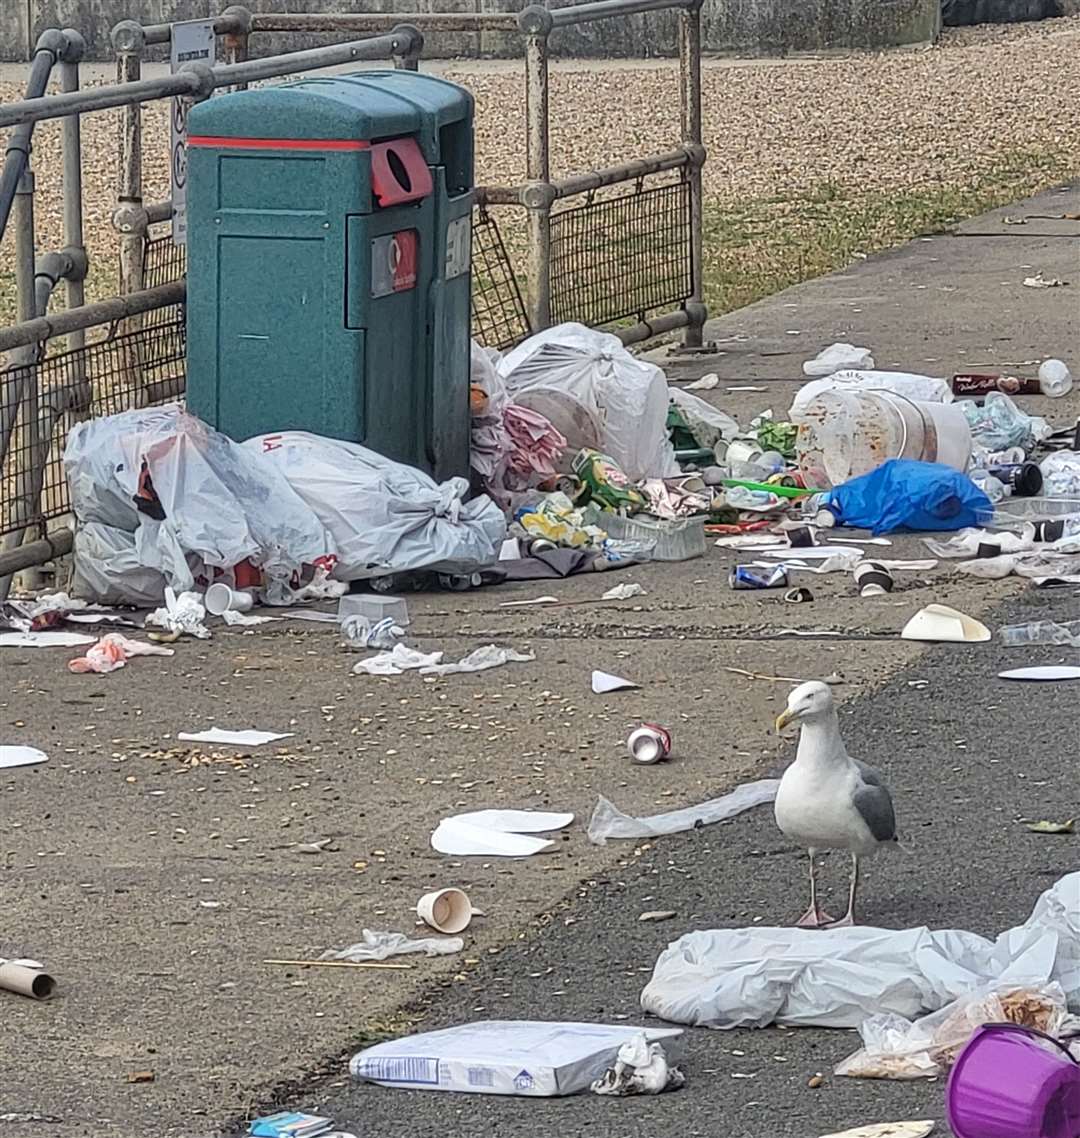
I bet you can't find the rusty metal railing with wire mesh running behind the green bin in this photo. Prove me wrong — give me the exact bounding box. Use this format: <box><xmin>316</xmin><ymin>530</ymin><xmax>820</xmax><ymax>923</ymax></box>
<box><xmin>0</xmin><ymin>0</ymin><xmax>706</xmax><ymax>596</ymax></box>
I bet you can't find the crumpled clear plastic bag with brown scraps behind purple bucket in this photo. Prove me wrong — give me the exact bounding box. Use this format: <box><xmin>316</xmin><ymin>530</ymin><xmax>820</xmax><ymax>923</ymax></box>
<box><xmin>835</xmin><ymin>984</ymin><xmax>1067</xmax><ymax>1080</ymax></box>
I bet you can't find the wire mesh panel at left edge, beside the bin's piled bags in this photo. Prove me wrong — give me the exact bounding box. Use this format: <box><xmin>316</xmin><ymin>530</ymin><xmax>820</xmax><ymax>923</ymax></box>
<box><xmin>0</xmin><ymin>306</ymin><xmax>186</xmax><ymax>535</ymax></box>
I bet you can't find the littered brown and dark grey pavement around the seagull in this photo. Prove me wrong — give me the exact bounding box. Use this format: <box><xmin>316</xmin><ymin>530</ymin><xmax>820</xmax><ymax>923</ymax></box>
<box><xmin>0</xmin><ymin>179</ymin><xmax>1080</xmax><ymax>1138</ymax></box>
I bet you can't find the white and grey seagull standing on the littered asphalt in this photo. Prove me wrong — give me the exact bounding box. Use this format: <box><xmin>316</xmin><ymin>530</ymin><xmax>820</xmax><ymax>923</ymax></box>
<box><xmin>775</xmin><ymin>681</ymin><xmax>897</xmax><ymax>929</ymax></box>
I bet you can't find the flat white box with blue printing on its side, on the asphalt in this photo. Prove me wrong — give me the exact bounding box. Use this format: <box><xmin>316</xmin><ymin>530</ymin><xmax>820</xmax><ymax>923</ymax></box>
<box><xmin>349</xmin><ymin>1020</ymin><xmax>682</xmax><ymax>1097</ymax></box>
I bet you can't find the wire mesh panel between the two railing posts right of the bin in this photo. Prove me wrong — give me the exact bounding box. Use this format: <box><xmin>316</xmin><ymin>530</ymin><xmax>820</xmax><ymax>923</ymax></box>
<box><xmin>551</xmin><ymin>180</ymin><xmax>693</xmax><ymax>327</ymax></box>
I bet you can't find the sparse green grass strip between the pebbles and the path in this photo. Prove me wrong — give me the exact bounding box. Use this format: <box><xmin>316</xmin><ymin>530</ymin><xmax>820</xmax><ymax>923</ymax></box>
<box><xmin>703</xmin><ymin>150</ymin><xmax>1078</xmax><ymax>316</ymax></box>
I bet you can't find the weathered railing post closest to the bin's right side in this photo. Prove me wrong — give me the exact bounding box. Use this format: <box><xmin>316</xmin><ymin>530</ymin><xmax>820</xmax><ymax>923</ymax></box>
<box><xmin>518</xmin><ymin>5</ymin><xmax>554</xmax><ymax>332</ymax></box>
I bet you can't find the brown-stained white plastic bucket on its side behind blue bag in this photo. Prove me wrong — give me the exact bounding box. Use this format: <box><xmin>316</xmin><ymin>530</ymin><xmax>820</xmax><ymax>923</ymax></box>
<box><xmin>792</xmin><ymin>390</ymin><xmax>972</xmax><ymax>489</ymax></box>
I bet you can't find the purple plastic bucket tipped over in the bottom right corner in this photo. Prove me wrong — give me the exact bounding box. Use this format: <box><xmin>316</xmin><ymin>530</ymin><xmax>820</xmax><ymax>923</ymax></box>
<box><xmin>946</xmin><ymin>1023</ymin><xmax>1080</xmax><ymax>1138</ymax></box>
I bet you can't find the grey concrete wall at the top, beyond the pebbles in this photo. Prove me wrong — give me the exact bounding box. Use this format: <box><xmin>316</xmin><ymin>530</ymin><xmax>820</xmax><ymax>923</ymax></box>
<box><xmin>0</xmin><ymin>0</ymin><xmax>940</xmax><ymax>60</ymax></box>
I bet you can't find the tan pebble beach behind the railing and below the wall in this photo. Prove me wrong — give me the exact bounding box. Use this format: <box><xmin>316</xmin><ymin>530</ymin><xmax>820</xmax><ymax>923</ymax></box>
<box><xmin>0</xmin><ymin>16</ymin><xmax>1080</xmax><ymax>311</ymax></box>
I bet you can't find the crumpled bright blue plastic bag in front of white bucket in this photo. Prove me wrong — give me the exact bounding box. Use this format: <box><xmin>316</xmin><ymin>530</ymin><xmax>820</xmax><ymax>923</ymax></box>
<box><xmin>825</xmin><ymin>459</ymin><xmax>994</xmax><ymax>535</ymax></box>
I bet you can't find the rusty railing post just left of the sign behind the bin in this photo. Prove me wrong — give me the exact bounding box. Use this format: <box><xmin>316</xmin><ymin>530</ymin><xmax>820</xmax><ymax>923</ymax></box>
<box><xmin>113</xmin><ymin>19</ymin><xmax>146</xmax><ymax>294</ymax></box>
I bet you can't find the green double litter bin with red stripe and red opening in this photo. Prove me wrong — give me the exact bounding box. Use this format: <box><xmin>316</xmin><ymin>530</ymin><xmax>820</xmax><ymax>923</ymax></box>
<box><xmin>187</xmin><ymin>71</ymin><xmax>473</xmax><ymax>479</ymax></box>
